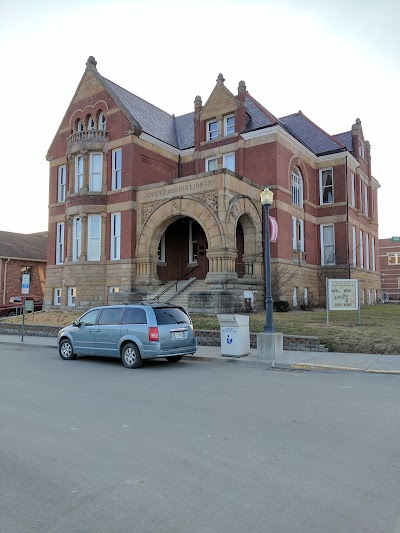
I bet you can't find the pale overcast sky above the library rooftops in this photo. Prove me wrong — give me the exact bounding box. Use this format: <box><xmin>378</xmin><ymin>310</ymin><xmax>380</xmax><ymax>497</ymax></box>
<box><xmin>0</xmin><ymin>0</ymin><xmax>400</xmax><ymax>238</ymax></box>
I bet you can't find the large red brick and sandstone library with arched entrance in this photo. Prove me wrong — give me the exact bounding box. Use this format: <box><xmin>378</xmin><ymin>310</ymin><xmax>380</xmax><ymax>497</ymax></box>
<box><xmin>45</xmin><ymin>57</ymin><xmax>380</xmax><ymax>312</ymax></box>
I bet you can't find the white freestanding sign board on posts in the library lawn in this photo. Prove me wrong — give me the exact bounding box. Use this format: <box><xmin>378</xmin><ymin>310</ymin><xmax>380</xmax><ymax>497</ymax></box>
<box><xmin>326</xmin><ymin>279</ymin><xmax>360</xmax><ymax>324</ymax></box>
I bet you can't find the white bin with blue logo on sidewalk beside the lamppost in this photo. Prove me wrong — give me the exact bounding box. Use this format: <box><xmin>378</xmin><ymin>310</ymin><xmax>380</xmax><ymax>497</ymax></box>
<box><xmin>217</xmin><ymin>315</ymin><xmax>250</xmax><ymax>357</ymax></box>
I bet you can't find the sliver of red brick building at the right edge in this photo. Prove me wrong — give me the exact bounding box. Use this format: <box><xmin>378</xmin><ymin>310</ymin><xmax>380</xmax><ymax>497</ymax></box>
<box><xmin>379</xmin><ymin>237</ymin><xmax>400</xmax><ymax>302</ymax></box>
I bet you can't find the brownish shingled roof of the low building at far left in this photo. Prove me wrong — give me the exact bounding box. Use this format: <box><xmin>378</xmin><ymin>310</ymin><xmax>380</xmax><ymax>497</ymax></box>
<box><xmin>0</xmin><ymin>231</ymin><xmax>47</xmax><ymax>261</ymax></box>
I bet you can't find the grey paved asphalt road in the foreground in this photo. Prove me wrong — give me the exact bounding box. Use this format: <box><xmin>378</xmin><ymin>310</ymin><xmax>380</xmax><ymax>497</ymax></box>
<box><xmin>0</xmin><ymin>345</ymin><xmax>400</xmax><ymax>533</ymax></box>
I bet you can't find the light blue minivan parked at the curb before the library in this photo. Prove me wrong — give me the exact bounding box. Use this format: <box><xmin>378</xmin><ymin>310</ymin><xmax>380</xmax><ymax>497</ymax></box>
<box><xmin>58</xmin><ymin>304</ymin><xmax>197</xmax><ymax>368</ymax></box>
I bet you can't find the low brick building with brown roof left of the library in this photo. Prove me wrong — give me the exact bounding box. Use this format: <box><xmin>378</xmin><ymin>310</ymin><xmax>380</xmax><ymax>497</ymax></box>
<box><xmin>0</xmin><ymin>231</ymin><xmax>47</xmax><ymax>304</ymax></box>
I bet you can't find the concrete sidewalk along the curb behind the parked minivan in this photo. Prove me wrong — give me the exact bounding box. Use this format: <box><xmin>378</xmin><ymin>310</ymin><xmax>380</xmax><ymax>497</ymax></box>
<box><xmin>0</xmin><ymin>335</ymin><xmax>400</xmax><ymax>375</ymax></box>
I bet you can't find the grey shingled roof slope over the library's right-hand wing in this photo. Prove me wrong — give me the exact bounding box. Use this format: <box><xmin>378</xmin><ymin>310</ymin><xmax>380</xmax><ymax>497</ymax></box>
<box><xmin>279</xmin><ymin>112</ymin><xmax>344</xmax><ymax>155</ymax></box>
